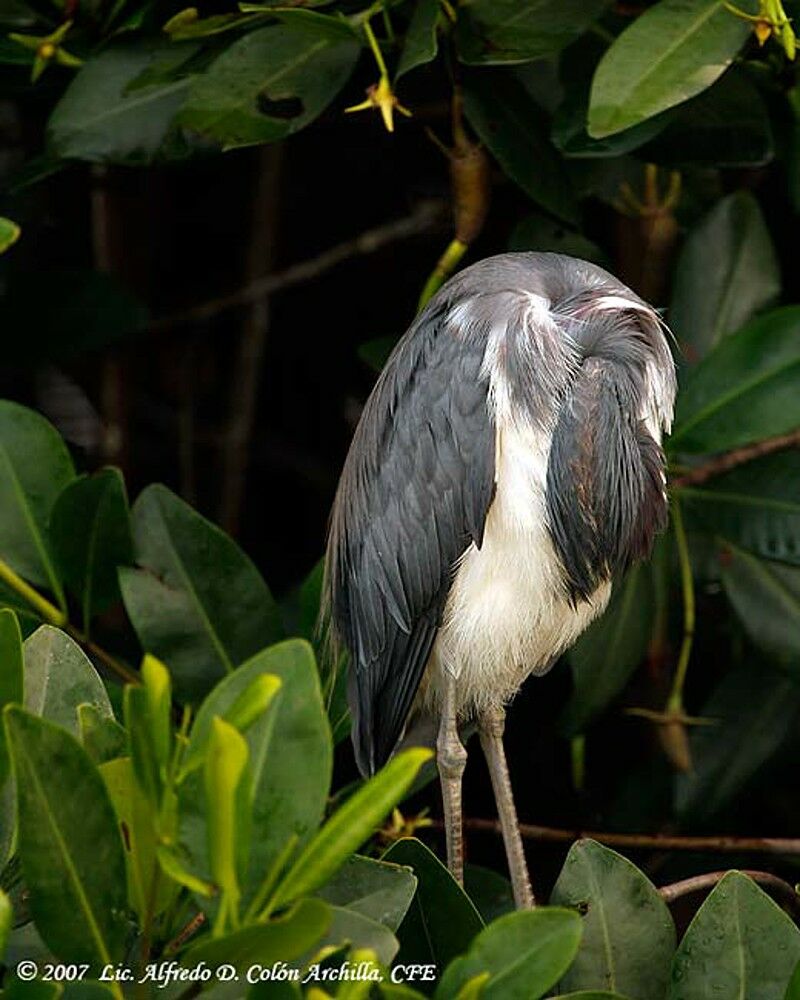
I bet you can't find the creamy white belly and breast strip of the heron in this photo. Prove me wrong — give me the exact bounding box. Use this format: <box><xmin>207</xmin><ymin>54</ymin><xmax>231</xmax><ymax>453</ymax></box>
<box><xmin>423</xmin><ymin>425</ymin><xmax>611</xmax><ymax>715</ymax></box>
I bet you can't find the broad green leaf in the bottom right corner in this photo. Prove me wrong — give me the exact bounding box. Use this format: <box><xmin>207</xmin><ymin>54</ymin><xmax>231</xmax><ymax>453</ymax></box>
<box><xmin>669</xmin><ymin>872</ymin><xmax>800</xmax><ymax>1000</ymax></box>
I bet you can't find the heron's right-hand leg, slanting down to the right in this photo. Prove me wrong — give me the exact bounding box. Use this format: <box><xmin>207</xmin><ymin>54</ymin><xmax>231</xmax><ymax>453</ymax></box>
<box><xmin>478</xmin><ymin>708</ymin><xmax>536</xmax><ymax>910</ymax></box>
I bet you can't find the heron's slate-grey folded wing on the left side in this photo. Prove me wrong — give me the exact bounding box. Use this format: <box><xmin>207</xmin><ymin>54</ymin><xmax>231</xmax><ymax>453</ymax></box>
<box><xmin>328</xmin><ymin>305</ymin><xmax>494</xmax><ymax>773</ymax></box>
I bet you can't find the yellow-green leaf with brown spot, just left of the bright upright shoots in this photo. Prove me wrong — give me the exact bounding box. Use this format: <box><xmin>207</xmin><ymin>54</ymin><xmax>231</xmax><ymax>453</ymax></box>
<box><xmin>98</xmin><ymin>757</ymin><xmax>176</xmax><ymax>922</ymax></box>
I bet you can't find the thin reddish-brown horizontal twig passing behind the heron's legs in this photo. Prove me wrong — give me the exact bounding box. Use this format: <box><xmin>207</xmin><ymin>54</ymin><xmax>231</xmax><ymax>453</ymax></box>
<box><xmin>444</xmin><ymin>817</ymin><xmax>800</xmax><ymax>855</ymax></box>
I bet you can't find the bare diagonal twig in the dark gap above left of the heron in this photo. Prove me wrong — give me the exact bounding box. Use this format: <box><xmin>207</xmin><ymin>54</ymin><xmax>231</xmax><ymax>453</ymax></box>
<box><xmin>150</xmin><ymin>201</ymin><xmax>447</xmax><ymax>333</ymax></box>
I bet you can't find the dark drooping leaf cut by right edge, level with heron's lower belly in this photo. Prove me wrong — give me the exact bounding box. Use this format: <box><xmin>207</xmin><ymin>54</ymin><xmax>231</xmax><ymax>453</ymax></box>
<box><xmin>722</xmin><ymin>549</ymin><xmax>800</xmax><ymax>682</ymax></box>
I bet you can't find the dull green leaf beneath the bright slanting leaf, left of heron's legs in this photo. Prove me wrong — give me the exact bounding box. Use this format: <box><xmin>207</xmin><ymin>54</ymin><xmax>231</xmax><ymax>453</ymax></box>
<box><xmin>318</xmin><ymin>854</ymin><xmax>417</xmax><ymax>931</ymax></box>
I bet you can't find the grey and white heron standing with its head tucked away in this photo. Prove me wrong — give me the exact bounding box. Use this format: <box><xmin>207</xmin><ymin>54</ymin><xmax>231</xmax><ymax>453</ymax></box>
<box><xmin>327</xmin><ymin>253</ymin><xmax>675</xmax><ymax>907</ymax></box>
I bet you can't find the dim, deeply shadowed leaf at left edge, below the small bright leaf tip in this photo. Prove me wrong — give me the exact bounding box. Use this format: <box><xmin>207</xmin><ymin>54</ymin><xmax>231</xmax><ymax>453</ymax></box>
<box><xmin>0</xmin><ymin>267</ymin><xmax>148</xmax><ymax>368</ymax></box>
